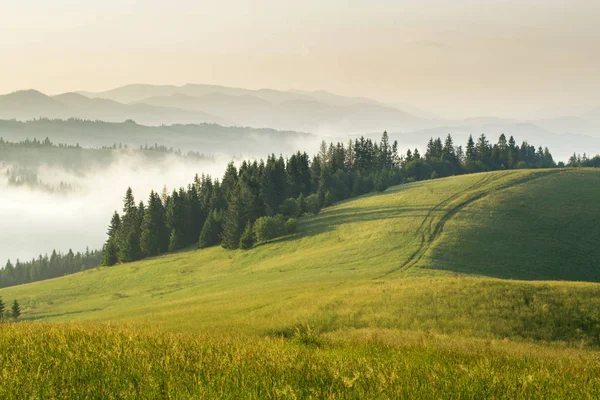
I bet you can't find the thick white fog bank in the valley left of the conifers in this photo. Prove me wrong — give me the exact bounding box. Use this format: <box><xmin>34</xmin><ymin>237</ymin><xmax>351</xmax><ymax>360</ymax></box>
<box><xmin>0</xmin><ymin>152</ymin><xmax>239</xmax><ymax>264</ymax></box>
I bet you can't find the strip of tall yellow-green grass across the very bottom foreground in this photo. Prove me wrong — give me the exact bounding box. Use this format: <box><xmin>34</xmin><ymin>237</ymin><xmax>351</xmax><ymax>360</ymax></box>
<box><xmin>0</xmin><ymin>323</ymin><xmax>600</xmax><ymax>399</ymax></box>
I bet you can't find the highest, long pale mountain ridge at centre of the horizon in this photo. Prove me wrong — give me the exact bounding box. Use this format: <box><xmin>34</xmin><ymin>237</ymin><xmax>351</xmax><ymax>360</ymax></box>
<box><xmin>80</xmin><ymin>84</ymin><xmax>430</xmax><ymax>133</ymax></box>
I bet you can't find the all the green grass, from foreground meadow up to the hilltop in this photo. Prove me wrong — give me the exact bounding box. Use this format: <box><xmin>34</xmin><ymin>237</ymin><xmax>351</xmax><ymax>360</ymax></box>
<box><xmin>0</xmin><ymin>170</ymin><xmax>600</xmax><ymax>398</ymax></box>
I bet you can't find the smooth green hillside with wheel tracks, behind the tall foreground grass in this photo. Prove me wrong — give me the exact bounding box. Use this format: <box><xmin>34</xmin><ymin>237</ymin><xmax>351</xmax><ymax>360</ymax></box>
<box><xmin>0</xmin><ymin>170</ymin><xmax>600</xmax><ymax>343</ymax></box>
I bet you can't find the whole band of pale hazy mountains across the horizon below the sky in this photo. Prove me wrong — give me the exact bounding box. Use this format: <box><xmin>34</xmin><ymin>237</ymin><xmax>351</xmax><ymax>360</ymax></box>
<box><xmin>0</xmin><ymin>84</ymin><xmax>600</xmax><ymax>159</ymax></box>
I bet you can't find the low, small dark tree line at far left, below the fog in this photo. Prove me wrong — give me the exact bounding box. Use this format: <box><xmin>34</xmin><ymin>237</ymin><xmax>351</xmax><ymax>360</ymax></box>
<box><xmin>0</xmin><ymin>249</ymin><xmax>102</xmax><ymax>287</ymax></box>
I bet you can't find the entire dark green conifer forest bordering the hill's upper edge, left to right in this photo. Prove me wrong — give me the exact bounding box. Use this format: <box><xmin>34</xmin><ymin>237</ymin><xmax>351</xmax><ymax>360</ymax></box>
<box><xmin>0</xmin><ymin>132</ymin><xmax>564</xmax><ymax>287</ymax></box>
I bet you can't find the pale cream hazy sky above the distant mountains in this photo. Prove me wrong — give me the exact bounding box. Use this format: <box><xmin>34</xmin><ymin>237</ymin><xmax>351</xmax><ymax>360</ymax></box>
<box><xmin>0</xmin><ymin>0</ymin><xmax>600</xmax><ymax>117</ymax></box>
